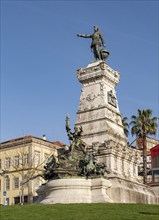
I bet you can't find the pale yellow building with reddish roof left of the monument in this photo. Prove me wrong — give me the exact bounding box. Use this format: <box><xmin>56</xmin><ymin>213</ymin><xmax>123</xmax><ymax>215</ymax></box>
<box><xmin>0</xmin><ymin>136</ymin><xmax>64</xmax><ymax>205</ymax></box>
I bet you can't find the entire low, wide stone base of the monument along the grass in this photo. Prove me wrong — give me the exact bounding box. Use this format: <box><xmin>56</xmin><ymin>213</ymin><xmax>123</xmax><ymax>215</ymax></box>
<box><xmin>36</xmin><ymin>175</ymin><xmax>159</xmax><ymax>204</ymax></box>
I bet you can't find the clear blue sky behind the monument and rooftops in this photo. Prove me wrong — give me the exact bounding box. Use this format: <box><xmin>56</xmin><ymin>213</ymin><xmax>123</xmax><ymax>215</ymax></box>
<box><xmin>1</xmin><ymin>0</ymin><xmax>159</xmax><ymax>143</ymax></box>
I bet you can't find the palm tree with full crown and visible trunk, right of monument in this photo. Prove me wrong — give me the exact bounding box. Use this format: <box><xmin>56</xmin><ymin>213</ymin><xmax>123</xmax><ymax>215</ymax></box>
<box><xmin>130</xmin><ymin>109</ymin><xmax>158</xmax><ymax>184</ymax></box>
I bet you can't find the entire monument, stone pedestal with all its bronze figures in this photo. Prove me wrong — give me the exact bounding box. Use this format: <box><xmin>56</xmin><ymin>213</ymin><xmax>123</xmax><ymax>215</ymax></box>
<box><xmin>37</xmin><ymin>26</ymin><xmax>159</xmax><ymax>204</ymax></box>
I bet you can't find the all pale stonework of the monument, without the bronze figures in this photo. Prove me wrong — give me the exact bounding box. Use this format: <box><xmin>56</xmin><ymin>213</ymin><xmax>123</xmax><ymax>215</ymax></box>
<box><xmin>37</xmin><ymin>61</ymin><xmax>159</xmax><ymax>204</ymax></box>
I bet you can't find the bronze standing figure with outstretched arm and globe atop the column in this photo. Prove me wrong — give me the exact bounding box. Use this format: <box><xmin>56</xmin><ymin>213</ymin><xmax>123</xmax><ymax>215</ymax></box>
<box><xmin>77</xmin><ymin>26</ymin><xmax>109</xmax><ymax>60</ymax></box>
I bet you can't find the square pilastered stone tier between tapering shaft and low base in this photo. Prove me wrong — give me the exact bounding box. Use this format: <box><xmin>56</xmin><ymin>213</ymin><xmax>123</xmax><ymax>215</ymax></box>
<box><xmin>91</xmin><ymin>140</ymin><xmax>140</xmax><ymax>181</ymax></box>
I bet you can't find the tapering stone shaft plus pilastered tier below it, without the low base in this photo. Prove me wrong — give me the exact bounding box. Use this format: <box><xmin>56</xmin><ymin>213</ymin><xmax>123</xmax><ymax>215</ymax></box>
<box><xmin>76</xmin><ymin>61</ymin><xmax>140</xmax><ymax>178</ymax></box>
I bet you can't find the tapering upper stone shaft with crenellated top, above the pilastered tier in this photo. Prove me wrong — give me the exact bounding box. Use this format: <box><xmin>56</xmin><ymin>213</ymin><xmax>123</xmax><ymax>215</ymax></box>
<box><xmin>76</xmin><ymin>60</ymin><xmax>127</xmax><ymax>145</ymax></box>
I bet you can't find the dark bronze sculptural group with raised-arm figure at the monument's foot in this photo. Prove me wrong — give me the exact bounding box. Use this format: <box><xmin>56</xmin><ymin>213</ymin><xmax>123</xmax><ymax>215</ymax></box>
<box><xmin>42</xmin><ymin>116</ymin><xmax>106</xmax><ymax>180</ymax></box>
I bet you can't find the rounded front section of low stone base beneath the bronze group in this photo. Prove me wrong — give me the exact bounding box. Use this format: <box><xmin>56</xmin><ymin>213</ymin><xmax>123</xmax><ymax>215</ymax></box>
<box><xmin>36</xmin><ymin>178</ymin><xmax>112</xmax><ymax>204</ymax></box>
